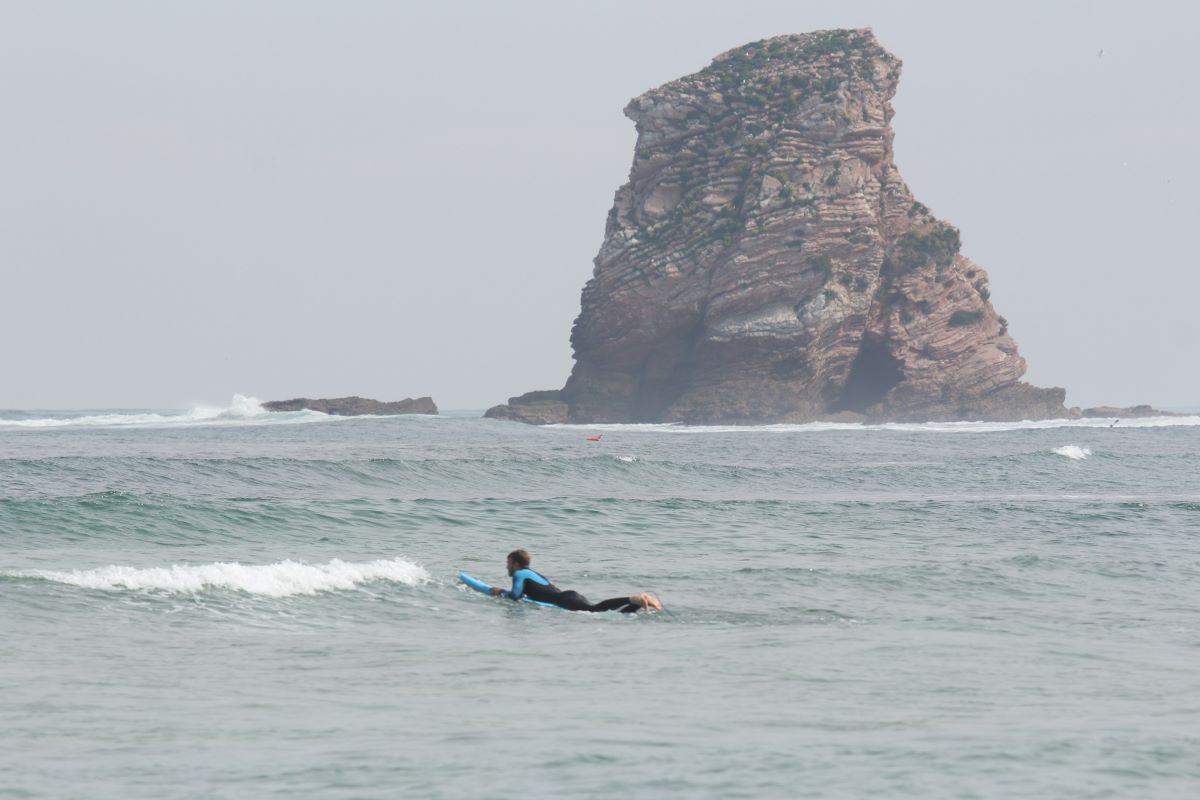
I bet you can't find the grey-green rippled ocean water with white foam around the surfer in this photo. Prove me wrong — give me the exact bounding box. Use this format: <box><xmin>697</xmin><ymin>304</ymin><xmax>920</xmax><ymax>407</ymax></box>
<box><xmin>0</xmin><ymin>397</ymin><xmax>1200</xmax><ymax>800</ymax></box>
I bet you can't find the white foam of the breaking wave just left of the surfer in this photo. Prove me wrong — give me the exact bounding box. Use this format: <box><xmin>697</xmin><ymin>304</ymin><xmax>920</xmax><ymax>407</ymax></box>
<box><xmin>5</xmin><ymin>559</ymin><xmax>430</xmax><ymax>597</ymax></box>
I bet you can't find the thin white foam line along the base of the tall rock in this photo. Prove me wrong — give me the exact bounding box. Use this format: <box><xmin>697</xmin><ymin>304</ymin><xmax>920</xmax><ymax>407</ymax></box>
<box><xmin>545</xmin><ymin>415</ymin><xmax>1200</xmax><ymax>434</ymax></box>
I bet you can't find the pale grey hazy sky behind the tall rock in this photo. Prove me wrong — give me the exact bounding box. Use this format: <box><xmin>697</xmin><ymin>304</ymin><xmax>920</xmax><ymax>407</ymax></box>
<box><xmin>0</xmin><ymin>0</ymin><xmax>1200</xmax><ymax>409</ymax></box>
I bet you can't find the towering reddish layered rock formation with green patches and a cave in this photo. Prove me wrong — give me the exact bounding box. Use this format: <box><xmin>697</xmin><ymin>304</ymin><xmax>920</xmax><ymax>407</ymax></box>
<box><xmin>487</xmin><ymin>30</ymin><xmax>1067</xmax><ymax>422</ymax></box>
